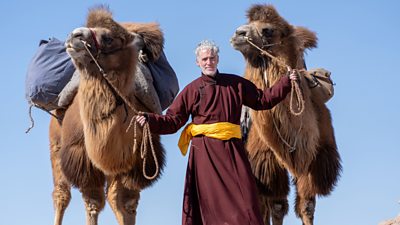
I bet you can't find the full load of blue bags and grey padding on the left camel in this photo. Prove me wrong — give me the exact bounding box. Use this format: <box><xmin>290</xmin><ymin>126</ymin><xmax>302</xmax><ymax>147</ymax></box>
<box><xmin>25</xmin><ymin>38</ymin><xmax>179</xmax><ymax>133</ymax></box>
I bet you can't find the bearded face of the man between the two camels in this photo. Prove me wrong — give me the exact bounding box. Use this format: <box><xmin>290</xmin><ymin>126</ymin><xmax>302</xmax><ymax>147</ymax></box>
<box><xmin>196</xmin><ymin>49</ymin><xmax>218</xmax><ymax>76</ymax></box>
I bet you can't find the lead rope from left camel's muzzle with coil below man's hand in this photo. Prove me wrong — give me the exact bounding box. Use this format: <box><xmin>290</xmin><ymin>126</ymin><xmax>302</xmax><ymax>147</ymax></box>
<box><xmin>81</xmin><ymin>40</ymin><xmax>160</xmax><ymax>180</ymax></box>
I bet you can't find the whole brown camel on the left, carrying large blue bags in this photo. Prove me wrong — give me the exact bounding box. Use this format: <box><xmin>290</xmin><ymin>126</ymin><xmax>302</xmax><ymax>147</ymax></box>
<box><xmin>49</xmin><ymin>7</ymin><xmax>165</xmax><ymax>225</ymax></box>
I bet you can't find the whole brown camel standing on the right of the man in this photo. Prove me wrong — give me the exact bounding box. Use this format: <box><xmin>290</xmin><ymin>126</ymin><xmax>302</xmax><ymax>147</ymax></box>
<box><xmin>231</xmin><ymin>4</ymin><xmax>342</xmax><ymax>225</ymax></box>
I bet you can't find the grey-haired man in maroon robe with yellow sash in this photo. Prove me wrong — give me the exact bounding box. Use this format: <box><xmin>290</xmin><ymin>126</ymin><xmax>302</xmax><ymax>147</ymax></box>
<box><xmin>136</xmin><ymin>41</ymin><xmax>298</xmax><ymax>225</ymax></box>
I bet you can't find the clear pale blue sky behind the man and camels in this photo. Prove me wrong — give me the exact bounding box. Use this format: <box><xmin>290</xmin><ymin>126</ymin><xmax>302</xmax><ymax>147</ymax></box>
<box><xmin>0</xmin><ymin>0</ymin><xmax>400</xmax><ymax>225</ymax></box>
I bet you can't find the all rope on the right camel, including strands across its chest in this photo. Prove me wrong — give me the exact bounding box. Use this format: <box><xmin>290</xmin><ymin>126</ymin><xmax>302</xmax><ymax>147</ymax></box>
<box><xmin>245</xmin><ymin>37</ymin><xmax>305</xmax><ymax>153</ymax></box>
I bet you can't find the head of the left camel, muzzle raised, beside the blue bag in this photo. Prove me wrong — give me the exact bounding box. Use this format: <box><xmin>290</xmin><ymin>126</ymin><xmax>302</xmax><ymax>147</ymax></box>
<box><xmin>65</xmin><ymin>6</ymin><xmax>137</xmax><ymax>75</ymax></box>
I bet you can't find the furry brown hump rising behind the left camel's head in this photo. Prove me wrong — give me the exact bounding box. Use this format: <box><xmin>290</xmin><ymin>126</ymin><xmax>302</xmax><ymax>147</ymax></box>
<box><xmin>121</xmin><ymin>23</ymin><xmax>164</xmax><ymax>61</ymax></box>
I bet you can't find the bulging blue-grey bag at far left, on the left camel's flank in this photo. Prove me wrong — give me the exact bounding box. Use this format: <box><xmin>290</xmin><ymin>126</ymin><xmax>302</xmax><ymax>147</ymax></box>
<box><xmin>25</xmin><ymin>38</ymin><xmax>75</xmax><ymax>111</ymax></box>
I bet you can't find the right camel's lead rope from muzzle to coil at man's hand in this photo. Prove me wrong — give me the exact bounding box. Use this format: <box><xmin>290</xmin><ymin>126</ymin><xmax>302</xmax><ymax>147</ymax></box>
<box><xmin>245</xmin><ymin>37</ymin><xmax>305</xmax><ymax>116</ymax></box>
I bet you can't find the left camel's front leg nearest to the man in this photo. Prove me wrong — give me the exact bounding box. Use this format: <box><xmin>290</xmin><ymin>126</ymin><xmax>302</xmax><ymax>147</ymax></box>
<box><xmin>107</xmin><ymin>178</ymin><xmax>140</xmax><ymax>225</ymax></box>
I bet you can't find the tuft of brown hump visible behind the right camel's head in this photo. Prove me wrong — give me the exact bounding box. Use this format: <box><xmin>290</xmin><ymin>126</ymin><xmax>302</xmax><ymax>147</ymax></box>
<box><xmin>292</xmin><ymin>27</ymin><xmax>318</xmax><ymax>52</ymax></box>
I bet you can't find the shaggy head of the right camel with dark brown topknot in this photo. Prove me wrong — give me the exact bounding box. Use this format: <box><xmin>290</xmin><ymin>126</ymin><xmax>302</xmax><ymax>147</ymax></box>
<box><xmin>231</xmin><ymin>4</ymin><xmax>317</xmax><ymax>68</ymax></box>
